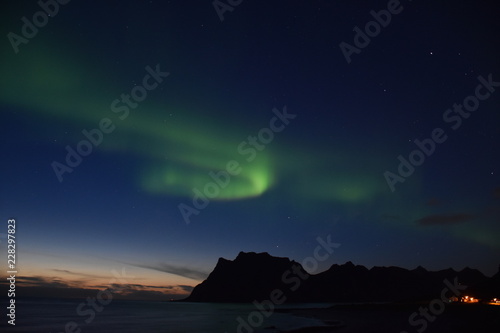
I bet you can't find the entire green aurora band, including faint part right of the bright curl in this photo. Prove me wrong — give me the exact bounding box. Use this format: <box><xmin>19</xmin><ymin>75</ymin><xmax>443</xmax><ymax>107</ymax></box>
<box><xmin>0</xmin><ymin>37</ymin><xmax>500</xmax><ymax>247</ymax></box>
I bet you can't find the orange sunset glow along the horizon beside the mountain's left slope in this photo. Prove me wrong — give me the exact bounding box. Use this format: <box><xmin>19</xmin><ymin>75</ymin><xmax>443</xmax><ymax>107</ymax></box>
<box><xmin>0</xmin><ymin>253</ymin><xmax>201</xmax><ymax>300</ymax></box>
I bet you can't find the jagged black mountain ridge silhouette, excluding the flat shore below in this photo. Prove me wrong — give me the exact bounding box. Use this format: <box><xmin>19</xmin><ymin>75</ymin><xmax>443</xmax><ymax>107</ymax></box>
<box><xmin>183</xmin><ymin>252</ymin><xmax>500</xmax><ymax>302</ymax></box>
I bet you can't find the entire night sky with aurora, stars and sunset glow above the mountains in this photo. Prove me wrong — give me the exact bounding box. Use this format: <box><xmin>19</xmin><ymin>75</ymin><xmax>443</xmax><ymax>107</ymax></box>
<box><xmin>0</xmin><ymin>0</ymin><xmax>500</xmax><ymax>297</ymax></box>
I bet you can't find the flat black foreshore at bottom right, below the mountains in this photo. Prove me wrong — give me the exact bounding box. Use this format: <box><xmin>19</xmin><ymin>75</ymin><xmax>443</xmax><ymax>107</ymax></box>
<box><xmin>282</xmin><ymin>303</ymin><xmax>500</xmax><ymax>333</ymax></box>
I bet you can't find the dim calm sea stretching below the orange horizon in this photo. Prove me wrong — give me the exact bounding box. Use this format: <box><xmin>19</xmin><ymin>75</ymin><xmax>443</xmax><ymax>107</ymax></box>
<box><xmin>0</xmin><ymin>299</ymin><xmax>330</xmax><ymax>333</ymax></box>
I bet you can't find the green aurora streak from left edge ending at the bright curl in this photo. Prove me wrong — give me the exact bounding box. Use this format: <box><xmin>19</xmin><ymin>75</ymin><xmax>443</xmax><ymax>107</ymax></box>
<box><xmin>0</xmin><ymin>42</ymin><xmax>274</xmax><ymax>200</ymax></box>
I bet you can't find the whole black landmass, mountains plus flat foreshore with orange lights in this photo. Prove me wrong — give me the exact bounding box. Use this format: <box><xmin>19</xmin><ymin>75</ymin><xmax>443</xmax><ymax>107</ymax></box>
<box><xmin>183</xmin><ymin>252</ymin><xmax>500</xmax><ymax>332</ymax></box>
